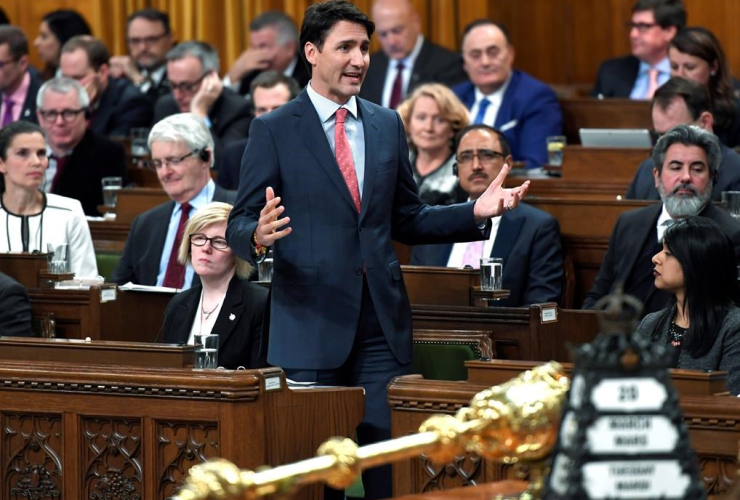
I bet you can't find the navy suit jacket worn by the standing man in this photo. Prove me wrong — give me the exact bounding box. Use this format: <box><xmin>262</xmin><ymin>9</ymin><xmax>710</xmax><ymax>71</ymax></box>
<box><xmin>227</xmin><ymin>90</ymin><xmax>490</xmax><ymax>370</ymax></box>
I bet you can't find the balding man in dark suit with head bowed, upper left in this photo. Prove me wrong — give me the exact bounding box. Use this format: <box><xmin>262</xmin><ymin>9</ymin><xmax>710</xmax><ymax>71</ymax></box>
<box><xmin>59</xmin><ymin>35</ymin><xmax>153</xmax><ymax>137</ymax></box>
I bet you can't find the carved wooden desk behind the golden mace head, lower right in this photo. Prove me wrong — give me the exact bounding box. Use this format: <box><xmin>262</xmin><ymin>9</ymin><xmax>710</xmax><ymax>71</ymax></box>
<box><xmin>388</xmin><ymin>360</ymin><xmax>740</xmax><ymax>497</ymax></box>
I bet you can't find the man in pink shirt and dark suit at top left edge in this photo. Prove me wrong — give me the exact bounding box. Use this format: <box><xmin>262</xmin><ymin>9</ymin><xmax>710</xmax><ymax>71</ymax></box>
<box><xmin>0</xmin><ymin>26</ymin><xmax>43</xmax><ymax>128</ymax></box>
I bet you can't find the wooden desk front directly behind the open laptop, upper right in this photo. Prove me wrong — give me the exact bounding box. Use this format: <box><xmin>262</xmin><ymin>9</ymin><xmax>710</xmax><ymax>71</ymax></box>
<box><xmin>560</xmin><ymin>98</ymin><xmax>653</xmax><ymax>144</ymax></box>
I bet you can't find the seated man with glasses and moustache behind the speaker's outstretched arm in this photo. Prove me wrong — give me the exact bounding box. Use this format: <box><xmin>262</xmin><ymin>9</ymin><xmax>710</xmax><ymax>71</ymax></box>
<box><xmin>411</xmin><ymin>125</ymin><xmax>563</xmax><ymax>307</ymax></box>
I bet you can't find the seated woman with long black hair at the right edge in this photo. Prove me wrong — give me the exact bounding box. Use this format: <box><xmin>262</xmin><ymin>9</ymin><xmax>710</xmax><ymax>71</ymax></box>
<box><xmin>637</xmin><ymin>217</ymin><xmax>740</xmax><ymax>394</ymax></box>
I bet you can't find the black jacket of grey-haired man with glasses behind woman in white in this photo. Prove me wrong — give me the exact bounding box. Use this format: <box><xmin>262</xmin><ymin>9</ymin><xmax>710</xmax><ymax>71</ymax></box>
<box><xmin>53</xmin><ymin>129</ymin><xmax>128</xmax><ymax>216</ymax></box>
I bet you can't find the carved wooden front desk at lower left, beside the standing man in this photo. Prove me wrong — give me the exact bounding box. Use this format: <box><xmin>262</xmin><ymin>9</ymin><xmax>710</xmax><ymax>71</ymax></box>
<box><xmin>0</xmin><ymin>339</ymin><xmax>364</xmax><ymax>500</ymax></box>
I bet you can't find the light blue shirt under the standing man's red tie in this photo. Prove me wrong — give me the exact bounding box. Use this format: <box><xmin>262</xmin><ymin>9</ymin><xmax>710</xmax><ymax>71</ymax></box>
<box><xmin>306</xmin><ymin>82</ymin><xmax>365</xmax><ymax>199</ymax></box>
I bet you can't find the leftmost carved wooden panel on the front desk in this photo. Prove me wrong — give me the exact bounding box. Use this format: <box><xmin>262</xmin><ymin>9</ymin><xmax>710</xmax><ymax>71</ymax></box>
<box><xmin>2</xmin><ymin>413</ymin><xmax>63</xmax><ymax>500</ymax></box>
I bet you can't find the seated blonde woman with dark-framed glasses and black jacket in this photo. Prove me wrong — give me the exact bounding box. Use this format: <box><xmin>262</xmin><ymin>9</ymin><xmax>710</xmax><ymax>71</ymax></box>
<box><xmin>163</xmin><ymin>203</ymin><xmax>267</xmax><ymax>370</ymax></box>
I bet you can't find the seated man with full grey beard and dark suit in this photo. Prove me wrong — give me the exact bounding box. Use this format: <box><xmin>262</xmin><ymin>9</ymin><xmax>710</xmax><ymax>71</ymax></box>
<box><xmin>583</xmin><ymin>125</ymin><xmax>740</xmax><ymax>314</ymax></box>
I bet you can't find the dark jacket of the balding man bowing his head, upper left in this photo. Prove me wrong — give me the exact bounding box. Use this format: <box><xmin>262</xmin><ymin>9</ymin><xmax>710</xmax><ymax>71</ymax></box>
<box><xmin>90</xmin><ymin>78</ymin><xmax>154</xmax><ymax>137</ymax></box>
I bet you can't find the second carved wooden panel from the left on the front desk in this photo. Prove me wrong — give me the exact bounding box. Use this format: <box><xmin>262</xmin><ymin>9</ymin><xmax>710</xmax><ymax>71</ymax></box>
<box><xmin>80</xmin><ymin>418</ymin><xmax>144</xmax><ymax>500</ymax></box>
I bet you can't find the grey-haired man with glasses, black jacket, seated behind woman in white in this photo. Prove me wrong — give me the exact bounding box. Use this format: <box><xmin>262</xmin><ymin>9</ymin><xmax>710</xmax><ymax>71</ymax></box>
<box><xmin>36</xmin><ymin>77</ymin><xmax>128</xmax><ymax>216</ymax></box>
